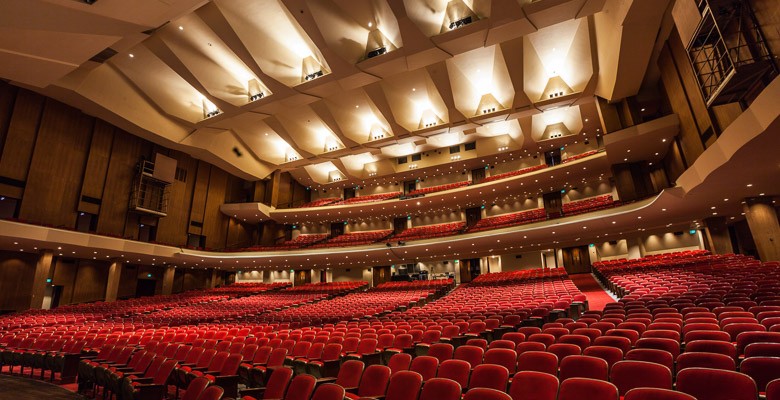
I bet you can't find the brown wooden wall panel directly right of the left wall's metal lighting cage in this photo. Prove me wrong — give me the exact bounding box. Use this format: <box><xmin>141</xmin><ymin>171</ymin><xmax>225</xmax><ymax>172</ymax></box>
<box><xmin>157</xmin><ymin>151</ymin><xmax>198</xmax><ymax>246</ymax></box>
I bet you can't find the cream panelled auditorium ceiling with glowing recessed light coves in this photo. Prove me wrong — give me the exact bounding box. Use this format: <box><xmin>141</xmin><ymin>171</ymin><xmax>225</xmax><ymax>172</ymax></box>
<box><xmin>0</xmin><ymin>0</ymin><xmax>668</xmax><ymax>185</ymax></box>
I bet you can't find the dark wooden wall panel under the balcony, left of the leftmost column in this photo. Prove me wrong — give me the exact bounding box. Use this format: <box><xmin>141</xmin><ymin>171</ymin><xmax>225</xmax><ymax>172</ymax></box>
<box><xmin>0</xmin><ymin>251</ymin><xmax>38</xmax><ymax>311</ymax></box>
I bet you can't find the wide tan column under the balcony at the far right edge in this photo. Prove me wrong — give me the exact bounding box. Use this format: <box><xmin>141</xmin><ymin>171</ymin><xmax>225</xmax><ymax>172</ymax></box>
<box><xmin>743</xmin><ymin>197</ymin><xmax>780</xmax><ymax>261</ymax></box>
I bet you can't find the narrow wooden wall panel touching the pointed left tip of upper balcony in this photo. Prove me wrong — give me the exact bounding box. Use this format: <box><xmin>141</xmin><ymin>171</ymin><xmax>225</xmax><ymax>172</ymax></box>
<box><xmin>203</xmin><ymin>167</ymin><xmax>228</xmax><ymax>249</ymax></box>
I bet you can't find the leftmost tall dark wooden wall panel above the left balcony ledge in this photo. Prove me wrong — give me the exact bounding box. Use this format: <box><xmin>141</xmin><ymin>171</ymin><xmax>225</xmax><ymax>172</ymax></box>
<box><xmin>0</xmin><ymin>90</ymin><xmax>45</xmax><ymax>185</ymax></box>
